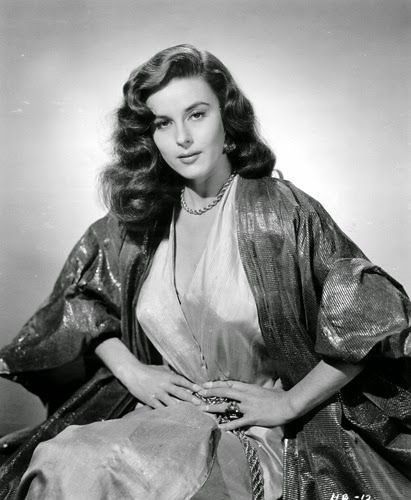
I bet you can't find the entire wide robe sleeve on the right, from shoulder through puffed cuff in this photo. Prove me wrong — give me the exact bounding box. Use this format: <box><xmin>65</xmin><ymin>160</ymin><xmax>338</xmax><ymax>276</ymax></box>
<box><xmin>298</xmin><ymin>188</ymin><xmax>411</xmax><ymax>363</ymax></box>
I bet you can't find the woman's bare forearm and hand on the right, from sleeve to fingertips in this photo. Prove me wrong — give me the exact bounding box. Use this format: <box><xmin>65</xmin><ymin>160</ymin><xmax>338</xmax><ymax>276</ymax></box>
<box><xmin>200</xmin><ymin>360</ymin><xmax>363</xmax><ymax>431</ymax></box>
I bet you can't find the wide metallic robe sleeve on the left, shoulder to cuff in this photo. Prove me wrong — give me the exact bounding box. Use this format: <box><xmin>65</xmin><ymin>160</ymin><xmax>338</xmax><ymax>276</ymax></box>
<box><xmin>0</xmin><ymin>212</ymin><xmax>121</xmax><ymax>382</ymax></box>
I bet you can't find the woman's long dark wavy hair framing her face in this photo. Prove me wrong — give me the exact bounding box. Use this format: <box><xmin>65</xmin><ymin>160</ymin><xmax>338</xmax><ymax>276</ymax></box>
<box><xmin>100</xmin><ymin>44</ymin><xmax>275</xmax><ymax>232</ymax></box>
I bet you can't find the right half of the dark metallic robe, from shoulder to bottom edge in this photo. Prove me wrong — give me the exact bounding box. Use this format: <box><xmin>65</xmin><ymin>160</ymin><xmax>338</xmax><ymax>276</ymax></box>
<box><xmin>237</xmin><ymin>178</ymin><xmax>411</xmax><ymax>500</ymax></box>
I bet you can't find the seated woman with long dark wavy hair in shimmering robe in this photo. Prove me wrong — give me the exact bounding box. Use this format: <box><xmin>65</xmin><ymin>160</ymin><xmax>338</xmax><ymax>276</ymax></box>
<box><xmin>0</xmin><ymin>45</ymin><xmax>411</xmax><ymax>500</ymax></box>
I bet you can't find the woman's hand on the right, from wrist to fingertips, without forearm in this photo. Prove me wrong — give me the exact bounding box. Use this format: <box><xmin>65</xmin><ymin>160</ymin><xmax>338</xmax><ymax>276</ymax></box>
<box><xmin>199</xmin><ymin>380</ymin><xmax>295</xmax><ymax>431</ymax></box>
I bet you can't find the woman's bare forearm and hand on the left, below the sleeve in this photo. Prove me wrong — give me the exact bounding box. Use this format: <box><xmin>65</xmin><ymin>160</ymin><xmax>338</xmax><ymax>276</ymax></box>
<box><xmin>95</xmin><ymin>338</ymin><xmax>201</xmax><ymax>408</ymax></box>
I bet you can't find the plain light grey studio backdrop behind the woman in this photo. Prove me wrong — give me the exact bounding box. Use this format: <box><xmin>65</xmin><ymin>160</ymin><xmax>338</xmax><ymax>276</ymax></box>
<box><xmin>0</xmin><ymin>0</ymin><xmax>411</xmax><ymax>434</ymax></box>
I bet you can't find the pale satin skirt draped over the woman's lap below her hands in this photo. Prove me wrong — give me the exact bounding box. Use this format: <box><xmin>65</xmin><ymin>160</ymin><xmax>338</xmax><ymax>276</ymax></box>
<box><xmin>18</xmin><ymin>404</ymin><xmax>250</xmax><ymax>500</ymax></box>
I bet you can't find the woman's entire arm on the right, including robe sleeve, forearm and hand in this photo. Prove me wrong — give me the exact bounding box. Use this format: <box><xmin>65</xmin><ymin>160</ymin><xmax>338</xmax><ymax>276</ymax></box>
<box><xmin>201</xmin><ymin>187</ymin><xmax>411</xmax><ymax>429</ymax></box>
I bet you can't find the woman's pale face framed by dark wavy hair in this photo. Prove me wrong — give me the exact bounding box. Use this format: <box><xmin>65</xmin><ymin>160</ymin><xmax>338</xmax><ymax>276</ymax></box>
<box><xmin>146</xmin><ymin>77</ymin><xmax>231</xmax><ymax>187</ymax></box>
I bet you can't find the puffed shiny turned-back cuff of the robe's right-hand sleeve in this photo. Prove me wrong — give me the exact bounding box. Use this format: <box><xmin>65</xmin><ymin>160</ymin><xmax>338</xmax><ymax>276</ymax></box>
<box><xmin>315</xmin><ymin>258</ymin><xmax>411</xmax><ymax>363</ymax></box>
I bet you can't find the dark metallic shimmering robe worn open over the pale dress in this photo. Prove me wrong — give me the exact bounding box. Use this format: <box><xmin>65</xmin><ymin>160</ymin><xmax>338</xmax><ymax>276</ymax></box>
<box><xmin>0</xmin><ymin>178</ymin><xmax>411</xmax><ymax>500</ymax></box>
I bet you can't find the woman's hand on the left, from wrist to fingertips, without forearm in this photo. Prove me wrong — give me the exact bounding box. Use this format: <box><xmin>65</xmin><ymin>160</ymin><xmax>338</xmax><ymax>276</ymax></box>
<box><xmin>117</xmin><ymin>360</ymin><xmax>201</xmax><ymax>408</ymax></box>
